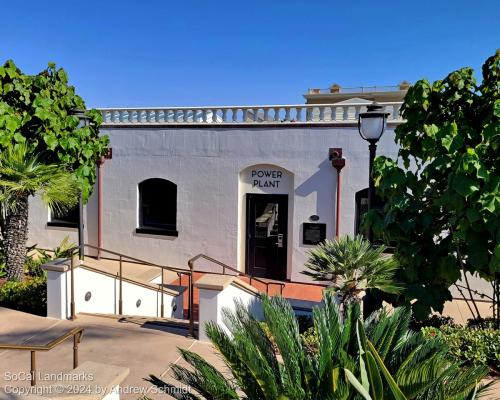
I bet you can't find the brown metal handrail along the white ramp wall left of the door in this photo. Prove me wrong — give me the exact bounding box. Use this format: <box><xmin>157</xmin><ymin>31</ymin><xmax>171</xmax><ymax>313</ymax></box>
<box><xmin>68</xmin><ymin>244</ymin><xmax>192</xmax><ymax>320</ymax></box>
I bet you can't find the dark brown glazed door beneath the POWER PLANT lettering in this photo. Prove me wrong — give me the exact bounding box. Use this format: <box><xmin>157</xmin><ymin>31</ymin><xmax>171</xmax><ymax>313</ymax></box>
<box><xmin>246</xmin><ymin>193</ymin><xmax>288</xmax><ymax>279</ymax></box>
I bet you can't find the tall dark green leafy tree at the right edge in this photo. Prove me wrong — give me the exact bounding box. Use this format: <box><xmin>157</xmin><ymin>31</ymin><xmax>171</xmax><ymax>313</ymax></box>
<box><xmin>366</xmin><ymin>52</ymin><xmax>500</xmax><ymax>318</ymax></box>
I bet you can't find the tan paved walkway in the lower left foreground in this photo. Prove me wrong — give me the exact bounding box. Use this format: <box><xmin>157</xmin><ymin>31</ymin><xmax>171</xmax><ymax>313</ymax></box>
<box><xmin>0</xmin><ymin>307</ymin><xmax>223</xmax><ymax>400</ymax></box>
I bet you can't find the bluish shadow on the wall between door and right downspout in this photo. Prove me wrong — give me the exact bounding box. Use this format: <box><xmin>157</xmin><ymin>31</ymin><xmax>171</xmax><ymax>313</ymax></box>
<box><xmin>295</xmin><ymin>160</ymin><xmax>337</xmax><ymax>247</ymax></box>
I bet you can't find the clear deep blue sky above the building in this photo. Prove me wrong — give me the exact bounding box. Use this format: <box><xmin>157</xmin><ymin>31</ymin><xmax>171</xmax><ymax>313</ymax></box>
<box><xmin>0</xmin><ymin>0</ymin><xmax>500</xmax><ymax>107</ymax></box>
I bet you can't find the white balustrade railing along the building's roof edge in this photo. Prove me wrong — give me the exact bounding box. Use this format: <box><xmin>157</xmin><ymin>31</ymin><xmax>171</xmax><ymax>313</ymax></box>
<box><xmin>100</xmin><ymin>102</ymin><xmax>402</xmax><ymax>125</ymax></box>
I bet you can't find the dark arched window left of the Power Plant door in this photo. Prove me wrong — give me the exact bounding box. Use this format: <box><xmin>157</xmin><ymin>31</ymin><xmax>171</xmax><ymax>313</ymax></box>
<box><xmin>137</xmin><ymin>178</ymin><xmax>178</xmax><ymax>236</ymax></box>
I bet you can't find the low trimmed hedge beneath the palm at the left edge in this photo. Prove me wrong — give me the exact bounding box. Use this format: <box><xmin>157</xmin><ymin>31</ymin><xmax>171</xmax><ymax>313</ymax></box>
<box><xmin>0</xmin><ymin>276</ymin><xmax>47</xmax><ymax>316</ymax></box>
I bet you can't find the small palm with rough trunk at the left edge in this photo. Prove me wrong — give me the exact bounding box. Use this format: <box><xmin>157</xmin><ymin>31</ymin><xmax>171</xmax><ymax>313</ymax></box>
<box><xmin>0</xmin><ymin>144</ymin><xmax>79</xmax><ymax>281</ymax></box>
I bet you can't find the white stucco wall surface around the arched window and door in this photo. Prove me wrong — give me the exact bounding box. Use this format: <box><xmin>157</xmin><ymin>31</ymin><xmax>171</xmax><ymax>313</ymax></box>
<box><xmin>30</xmin><ymin>125</ymin><xmax>397</xmax><ymax>281</ymax></box>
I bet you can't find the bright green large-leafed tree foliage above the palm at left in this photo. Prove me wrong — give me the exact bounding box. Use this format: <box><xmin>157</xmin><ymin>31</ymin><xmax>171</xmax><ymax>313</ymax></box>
<box><xmin>0</xmin><ymin>60</ymin><xmax>109</xmax><ymax>200</ymax></box>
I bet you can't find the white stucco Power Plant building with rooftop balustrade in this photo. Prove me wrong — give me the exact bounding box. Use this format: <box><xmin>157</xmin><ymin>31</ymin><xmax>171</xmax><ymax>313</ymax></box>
<box><xmin>29</xmin><ymin>87</ymin><xmax>405</xmax><ymax>281</ymax></box>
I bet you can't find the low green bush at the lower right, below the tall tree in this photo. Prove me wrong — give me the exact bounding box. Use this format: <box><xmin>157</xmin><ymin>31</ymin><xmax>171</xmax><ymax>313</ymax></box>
<box><xmin>422</xmin><ymin>326</ymin><xmax>500</xmax><ymax>372</ymax></box>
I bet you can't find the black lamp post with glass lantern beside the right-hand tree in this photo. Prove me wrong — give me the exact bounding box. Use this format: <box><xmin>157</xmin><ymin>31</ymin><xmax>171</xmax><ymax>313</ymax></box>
<box><xmin>358</xmin><ymin>103</ymin><xmax>389</xmax><ymax>243</ymax></box>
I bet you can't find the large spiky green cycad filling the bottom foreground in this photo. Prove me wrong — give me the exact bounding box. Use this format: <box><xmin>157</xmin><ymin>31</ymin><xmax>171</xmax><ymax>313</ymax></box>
<box><xmin>147</xmin><ymin>293</ymin><xmax>488</xmax><ymax>400</ymax></box>
